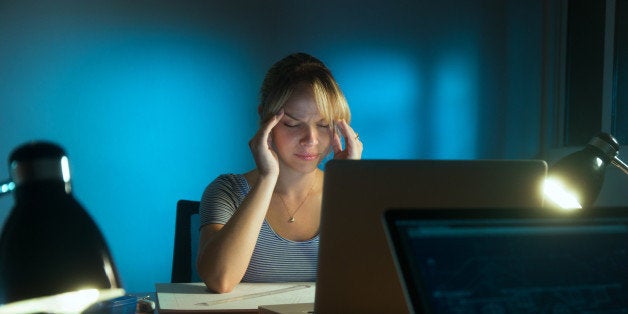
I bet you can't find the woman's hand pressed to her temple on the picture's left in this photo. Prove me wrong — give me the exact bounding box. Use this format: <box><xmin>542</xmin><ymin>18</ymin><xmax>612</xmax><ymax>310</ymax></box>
<box><xmin>249</xmin><ymin>109</ymin><xmax>284</xmax><ymax>176</ymax></box>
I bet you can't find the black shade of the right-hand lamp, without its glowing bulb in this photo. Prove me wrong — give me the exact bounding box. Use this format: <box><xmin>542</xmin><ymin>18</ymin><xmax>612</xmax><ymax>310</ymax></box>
<box><xmin>548</xmin><ymin>133</ymin><xmax>619</xmax><ymax>208</ymax></box>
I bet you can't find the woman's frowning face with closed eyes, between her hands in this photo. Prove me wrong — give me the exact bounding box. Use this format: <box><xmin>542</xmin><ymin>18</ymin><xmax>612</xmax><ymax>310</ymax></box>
<box><xmin>272</xmin><ymin>85</ymin><xmax>333</xmax><ymax>172</ymax></box>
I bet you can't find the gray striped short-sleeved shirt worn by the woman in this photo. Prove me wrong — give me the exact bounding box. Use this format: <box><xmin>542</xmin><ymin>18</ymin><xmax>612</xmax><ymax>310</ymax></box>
<box><xmin>199</xmin><ymin>174</ymin><xmax>319</xmax><ymax>282</ymax></box>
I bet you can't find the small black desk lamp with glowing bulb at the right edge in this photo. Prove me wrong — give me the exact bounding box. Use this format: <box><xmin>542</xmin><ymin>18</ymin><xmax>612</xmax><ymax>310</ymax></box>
<box><xmin>545</xmin><ymin>133</ymin><xmax>628</xmax><ymax>209</ymax></box>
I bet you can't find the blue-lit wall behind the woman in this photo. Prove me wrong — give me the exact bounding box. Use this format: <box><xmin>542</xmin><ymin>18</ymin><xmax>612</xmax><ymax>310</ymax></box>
<box><xmin>0</xmin><ymin>0</ymin><xmax>543</xmax><ymax>291</ymax></box>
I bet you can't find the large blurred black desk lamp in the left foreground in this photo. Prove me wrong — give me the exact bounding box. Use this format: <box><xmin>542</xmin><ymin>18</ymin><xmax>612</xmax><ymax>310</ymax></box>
<box><xmin>0</xmin><ymin>142</ymin><xmax>124</xmax><ymax>313</ymax></box>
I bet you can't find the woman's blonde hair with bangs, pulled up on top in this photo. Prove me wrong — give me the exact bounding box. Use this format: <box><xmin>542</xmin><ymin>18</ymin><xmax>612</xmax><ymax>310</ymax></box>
<box><xmin>259</xmin><ymin>52</ymin><xmax>351</xmax><ymax>123</ymax></box>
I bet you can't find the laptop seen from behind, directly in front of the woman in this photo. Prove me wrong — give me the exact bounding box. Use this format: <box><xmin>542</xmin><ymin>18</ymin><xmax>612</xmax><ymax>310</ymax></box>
<box><xmin>314</xmin><ymin>160</ymin><xmax>547</xmax><ymax>314</ymax></box>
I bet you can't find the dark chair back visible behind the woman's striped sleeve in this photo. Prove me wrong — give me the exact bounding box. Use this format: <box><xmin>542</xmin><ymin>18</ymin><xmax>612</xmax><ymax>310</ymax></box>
<box><xmin>170</xmin><ymin>200</ymin><xmax>201</xmax><ymax>282</ymax></box>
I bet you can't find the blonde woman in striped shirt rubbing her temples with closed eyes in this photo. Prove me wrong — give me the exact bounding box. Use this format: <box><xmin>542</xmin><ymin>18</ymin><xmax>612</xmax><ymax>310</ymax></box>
<box><xmin>197</xmin><ymin>53</ymin><xmax>362</xmax><ymax>293</ymax></box>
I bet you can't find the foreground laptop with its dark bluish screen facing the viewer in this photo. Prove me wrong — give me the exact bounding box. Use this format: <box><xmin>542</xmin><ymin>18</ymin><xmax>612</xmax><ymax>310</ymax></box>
<box><xmin>384</xmin><ymin>207</ymin><xmax>628</xmax><ymax>313</ymax></box>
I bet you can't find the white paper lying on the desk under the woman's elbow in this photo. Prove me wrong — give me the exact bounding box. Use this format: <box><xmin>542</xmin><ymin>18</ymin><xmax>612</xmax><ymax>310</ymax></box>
<box><xmin>155</xmin><ymin>282</ymin><xmax>316</xmax><ymax>314</ymax></box>
